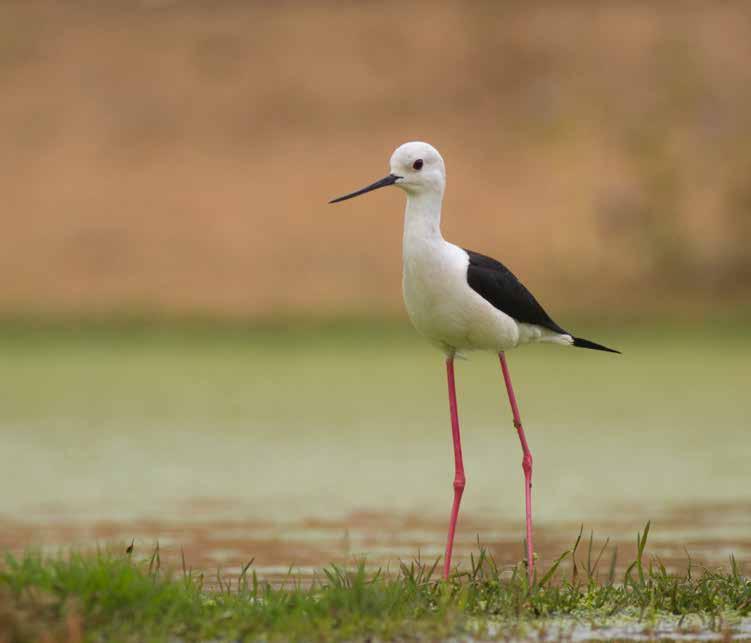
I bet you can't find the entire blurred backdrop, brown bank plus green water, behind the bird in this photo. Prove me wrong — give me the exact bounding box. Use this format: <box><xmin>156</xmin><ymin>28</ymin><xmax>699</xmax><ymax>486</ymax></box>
<box><xmin>0</xmin><ymin>0</ymin><xmax>751</xmax><ymax>573</ymax></box>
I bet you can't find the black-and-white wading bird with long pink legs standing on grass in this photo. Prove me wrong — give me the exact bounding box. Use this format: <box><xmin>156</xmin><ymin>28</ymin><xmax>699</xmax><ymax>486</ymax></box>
<box><xmin>329</xmin><ymin>141</ymin><xmax>620</xmax><ymax>584</ymax></box>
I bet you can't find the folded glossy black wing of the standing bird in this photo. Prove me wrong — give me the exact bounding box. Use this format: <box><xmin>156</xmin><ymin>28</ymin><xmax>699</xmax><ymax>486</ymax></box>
<box><xmin>464</xmin><ymin>248</ymin><xmax>568</xmax><ymax>334</ymax></box>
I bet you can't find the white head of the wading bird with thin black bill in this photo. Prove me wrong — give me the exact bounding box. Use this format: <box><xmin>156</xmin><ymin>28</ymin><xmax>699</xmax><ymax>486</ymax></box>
<box><xmin>329</xmin><ymin>141</ymin><xmax>446</xmax><ymax>203</ymax></box>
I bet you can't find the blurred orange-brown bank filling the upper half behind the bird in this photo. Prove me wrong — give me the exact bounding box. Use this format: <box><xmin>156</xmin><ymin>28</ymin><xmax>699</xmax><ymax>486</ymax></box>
<box><xmin>0</xmin><ymin>0</ymin><xmax>751</xmax><ymax>318</ymax></box>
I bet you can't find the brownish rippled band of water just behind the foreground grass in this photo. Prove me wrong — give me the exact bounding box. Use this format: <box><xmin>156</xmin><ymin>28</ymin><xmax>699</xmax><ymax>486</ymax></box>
<box><xmin>0</xmin><ymin>502</ymin><xmax>751</xmax><ymax>583</ymax></box>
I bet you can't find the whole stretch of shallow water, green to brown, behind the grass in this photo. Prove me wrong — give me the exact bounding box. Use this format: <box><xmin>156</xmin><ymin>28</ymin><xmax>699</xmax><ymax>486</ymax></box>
<box><xmin>0</xmin><ymin>324</ymin><xmax>751</xmax><ymax>575</ymax></box>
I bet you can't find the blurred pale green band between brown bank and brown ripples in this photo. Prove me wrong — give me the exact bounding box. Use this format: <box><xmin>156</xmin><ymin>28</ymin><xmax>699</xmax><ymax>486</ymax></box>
<box><xmin>0</xmin><ymin>318</ymin><xmax>751</xmax><ymax>520</ymax></box>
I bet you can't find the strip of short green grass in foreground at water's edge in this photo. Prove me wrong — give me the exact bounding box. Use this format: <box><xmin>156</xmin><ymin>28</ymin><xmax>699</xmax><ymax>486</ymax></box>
<box><xmin>0</xmin><ymin>525</ymin><xmax>751</xmax><ymax>641</ymax></box>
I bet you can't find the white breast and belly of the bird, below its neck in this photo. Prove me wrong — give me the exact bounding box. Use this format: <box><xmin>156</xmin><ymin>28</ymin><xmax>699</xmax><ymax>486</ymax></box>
<box><xmin>402</xmin><ymin>239</ymin><xmax>520</xmax><ymax>353</ymax></box>
